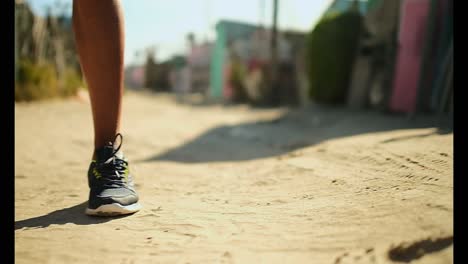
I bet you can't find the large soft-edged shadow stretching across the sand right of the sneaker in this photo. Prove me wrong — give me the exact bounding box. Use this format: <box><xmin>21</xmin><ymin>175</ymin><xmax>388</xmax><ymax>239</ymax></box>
<box><xmin>144</xmin><ymin>106</ymin><xmax>452</xmax><ymax>163</ymax></box>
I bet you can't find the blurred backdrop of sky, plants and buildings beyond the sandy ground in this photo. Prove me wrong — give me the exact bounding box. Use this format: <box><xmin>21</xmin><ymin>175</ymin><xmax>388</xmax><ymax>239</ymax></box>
<box><xmin>15</xmin><ymin>0</ymin><xmax>453</xmax><ymax>113</ymax></box>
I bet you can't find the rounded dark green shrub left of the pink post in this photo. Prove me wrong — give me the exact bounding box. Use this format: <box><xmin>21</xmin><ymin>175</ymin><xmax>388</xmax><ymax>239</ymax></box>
<box><xmin>306</xmin><ymin>10</ymin><xmax>362</xmax><ymax>103</ymax></box>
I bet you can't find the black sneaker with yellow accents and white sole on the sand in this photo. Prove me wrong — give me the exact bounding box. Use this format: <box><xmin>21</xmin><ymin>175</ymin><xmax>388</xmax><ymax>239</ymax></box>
<box><xmin>86</xmin><ymin>134</ymin><xmax>141</xmax><ymax>216</ymax></box>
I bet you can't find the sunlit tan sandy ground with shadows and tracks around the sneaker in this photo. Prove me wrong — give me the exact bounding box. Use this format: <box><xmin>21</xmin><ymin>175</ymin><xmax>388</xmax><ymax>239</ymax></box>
<box><xmin>15</xmin><ymin>93</ymin><xmax>453</xmax><ymax>264</ymax></box>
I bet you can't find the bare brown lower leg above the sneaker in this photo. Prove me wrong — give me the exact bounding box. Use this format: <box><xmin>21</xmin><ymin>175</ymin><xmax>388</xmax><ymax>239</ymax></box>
<box><xmin>73</xmin><ymin>0</ymin><xmax>124</xmax><ymax>152</ymax></box>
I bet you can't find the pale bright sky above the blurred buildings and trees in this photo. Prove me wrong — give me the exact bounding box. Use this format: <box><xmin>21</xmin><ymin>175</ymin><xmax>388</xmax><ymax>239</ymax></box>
<box><xmin>27</xmin><ymin>0</ymin><xmax>332</xmax><ymax>66</ymax></box>
